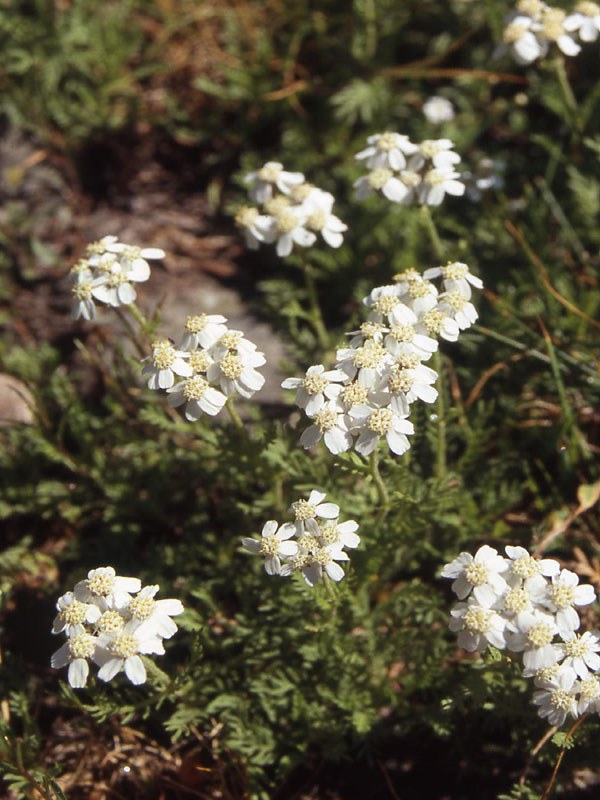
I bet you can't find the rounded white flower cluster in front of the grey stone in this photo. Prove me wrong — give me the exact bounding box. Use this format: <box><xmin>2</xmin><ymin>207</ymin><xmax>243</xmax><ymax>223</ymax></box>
<box><xmin>142</xmin><ymin>314</ymin><xmax>266</xmax><ymax>422</ymax></box>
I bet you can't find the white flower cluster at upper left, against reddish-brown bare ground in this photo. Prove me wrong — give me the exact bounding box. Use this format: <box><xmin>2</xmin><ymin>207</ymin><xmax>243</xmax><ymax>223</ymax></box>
<box><xmin>71</xmin><ymin>236</ymin><xmax>165</xmax><ymax>320</ymax></box>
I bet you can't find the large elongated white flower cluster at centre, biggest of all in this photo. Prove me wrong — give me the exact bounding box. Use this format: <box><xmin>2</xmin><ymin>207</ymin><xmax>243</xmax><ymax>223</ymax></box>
<box><xmin>281</xmin><ymin>262</ymin><xmax>483</xmax><ymax>456</ymax></box>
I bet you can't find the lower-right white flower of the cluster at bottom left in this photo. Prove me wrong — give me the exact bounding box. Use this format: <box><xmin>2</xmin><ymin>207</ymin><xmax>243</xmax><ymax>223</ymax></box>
<box><xmin>93</xmin><ymin>619</ymin><xmax>165</xmax><ymax>686</ymax></box>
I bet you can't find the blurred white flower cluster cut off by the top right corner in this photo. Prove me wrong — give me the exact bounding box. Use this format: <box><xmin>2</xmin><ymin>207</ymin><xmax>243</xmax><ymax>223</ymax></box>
<box><xmin>494</xmin><ymin>0</ymin><xmax>600</xmax><ymax>65</ymax></box>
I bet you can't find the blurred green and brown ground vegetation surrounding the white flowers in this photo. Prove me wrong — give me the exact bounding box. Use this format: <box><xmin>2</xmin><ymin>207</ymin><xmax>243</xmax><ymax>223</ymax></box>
<box><xmin>0</xmin><ymin>0</ymin><xmax>600</xmax><ymax>800</ymax></box>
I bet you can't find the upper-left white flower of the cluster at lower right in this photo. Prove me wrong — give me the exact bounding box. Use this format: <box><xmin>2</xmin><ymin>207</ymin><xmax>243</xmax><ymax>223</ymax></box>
<box><xmin>441</xmin><ymin>544</ymin><xmax>508</xmax><ymax>608</ymax></box>
